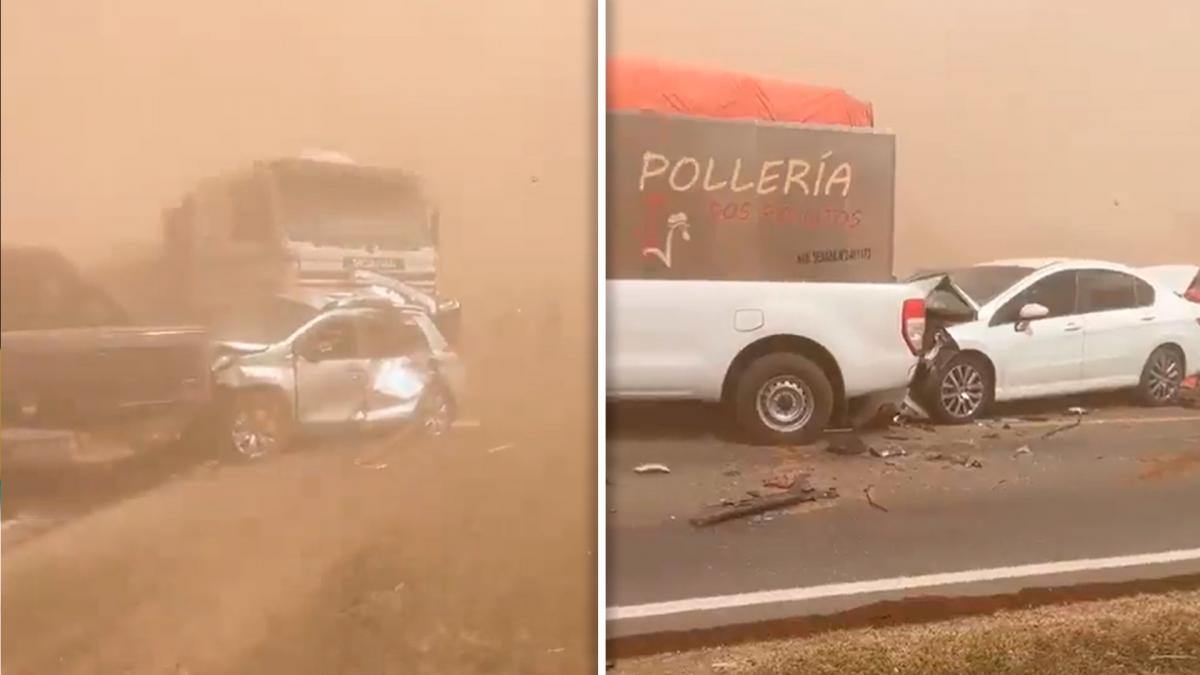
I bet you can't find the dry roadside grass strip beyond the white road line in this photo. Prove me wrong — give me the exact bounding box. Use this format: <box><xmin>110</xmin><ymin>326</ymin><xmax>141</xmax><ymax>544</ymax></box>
<box><xmin>610</xmin><ymin>591</ymin><xmax>1200</xmax><ymax>675</ymax></box>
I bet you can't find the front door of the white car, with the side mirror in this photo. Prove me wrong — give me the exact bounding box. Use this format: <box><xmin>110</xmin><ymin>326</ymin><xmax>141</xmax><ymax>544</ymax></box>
<box><xmin>986</xmin><ymin>270</ymin><xmax>1084</xmax><ymax>399</ymax></box>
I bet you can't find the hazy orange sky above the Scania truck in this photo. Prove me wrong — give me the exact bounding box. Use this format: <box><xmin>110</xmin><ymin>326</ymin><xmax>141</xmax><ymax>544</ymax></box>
<box><xmin>0</xmin><ymin>0</ymin><xmax>595</xmax><ymax>306</ymax></box>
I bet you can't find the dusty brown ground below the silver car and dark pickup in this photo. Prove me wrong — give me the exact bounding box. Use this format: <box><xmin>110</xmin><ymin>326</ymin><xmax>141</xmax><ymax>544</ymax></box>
<box><xmin>2</xmin><ymin>314</ymin><xmax>596</xmax><ymax>675</ymax></box>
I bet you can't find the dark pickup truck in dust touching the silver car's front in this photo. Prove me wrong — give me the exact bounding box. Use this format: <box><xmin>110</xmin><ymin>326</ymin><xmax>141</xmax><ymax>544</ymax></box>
<box><xmin>0</xmin><ymin>247</ymin><xmax>212</xmax><ymax>455</ymax></box>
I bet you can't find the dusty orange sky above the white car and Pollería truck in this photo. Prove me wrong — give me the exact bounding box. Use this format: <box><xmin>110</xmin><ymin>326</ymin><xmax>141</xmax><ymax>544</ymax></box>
<box><xmin>608</xmin><ymin>0</ymin><xmax>1200</xmax><ymax>274</ymax></box>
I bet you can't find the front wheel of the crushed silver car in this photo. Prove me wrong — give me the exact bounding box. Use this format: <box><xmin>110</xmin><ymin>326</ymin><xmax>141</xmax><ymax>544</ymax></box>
<box><xmin>221</xmin><ymin>389</ymin><xmax>295</xmax><ymax>461</ymax></box>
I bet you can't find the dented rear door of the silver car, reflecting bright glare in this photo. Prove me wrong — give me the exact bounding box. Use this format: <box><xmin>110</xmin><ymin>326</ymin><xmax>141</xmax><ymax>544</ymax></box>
<box><xmin>360</xmin><ymin>310</ymin><xmax>433</xmax><ymax>423</ymax></box>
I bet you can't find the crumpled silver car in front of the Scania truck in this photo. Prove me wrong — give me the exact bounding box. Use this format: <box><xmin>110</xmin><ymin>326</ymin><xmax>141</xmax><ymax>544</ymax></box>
<box><xmin>212</xmin><ymin>287</ymin><xmax>464</xmax><ymax>458</ymax></box>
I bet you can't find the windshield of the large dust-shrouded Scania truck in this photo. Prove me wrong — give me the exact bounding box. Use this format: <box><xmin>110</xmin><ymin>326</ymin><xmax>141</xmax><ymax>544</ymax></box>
<box><xmin>272</xmin><ymin>162</ymin><xmax>432</xmax><ymax>251</ymax></box>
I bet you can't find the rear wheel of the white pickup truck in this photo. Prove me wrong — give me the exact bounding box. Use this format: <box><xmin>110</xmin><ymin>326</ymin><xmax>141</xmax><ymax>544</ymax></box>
<box><xmin>732</xmin><ymin>352</ymin><xmax>834</xmax><ymax>444</ymax></box>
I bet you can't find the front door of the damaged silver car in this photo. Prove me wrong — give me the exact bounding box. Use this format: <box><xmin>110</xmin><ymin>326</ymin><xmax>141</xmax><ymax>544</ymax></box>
<box><xmin>294</xmin><ymin>312</ymin><xmax>368</xmax><ymax>425</ymax></box>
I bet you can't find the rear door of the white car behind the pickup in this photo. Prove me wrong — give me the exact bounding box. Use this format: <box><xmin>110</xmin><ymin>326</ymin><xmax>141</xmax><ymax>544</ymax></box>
<box><xmin>1079</xmin><ymin>269</ymin><xmax>1162</xmax><ymax>389</ymax></box>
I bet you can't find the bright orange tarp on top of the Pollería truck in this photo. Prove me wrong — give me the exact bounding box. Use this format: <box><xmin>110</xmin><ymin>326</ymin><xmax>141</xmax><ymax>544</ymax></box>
<box><xmin>608</xmin><ymin>59</ymin><xmax>875</xmax><ymax>126</ymax></box>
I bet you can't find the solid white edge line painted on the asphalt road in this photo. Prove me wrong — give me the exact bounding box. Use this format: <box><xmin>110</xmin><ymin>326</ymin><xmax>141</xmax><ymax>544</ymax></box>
<box><xmin>606</xmin><ymin>549</ymin><xmax>1200</xmax><ymax>621</ymax></box>
